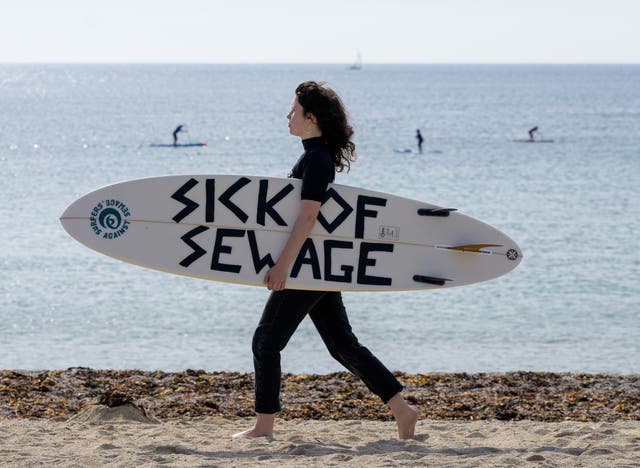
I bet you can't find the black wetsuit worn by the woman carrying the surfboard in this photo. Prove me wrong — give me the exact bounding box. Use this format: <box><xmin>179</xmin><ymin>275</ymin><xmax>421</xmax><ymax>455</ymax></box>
<box><xmin>252</xmin><ymin>138</ymin><xmax>402</xmax><ymax>414</ymax></box>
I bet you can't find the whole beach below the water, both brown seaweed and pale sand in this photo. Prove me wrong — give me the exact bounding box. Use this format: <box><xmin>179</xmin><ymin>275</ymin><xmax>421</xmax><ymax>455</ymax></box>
<box><xmin>0</xmin><ymin>368</ymin><xmax>640</xmax><ymax>467</ymax></box>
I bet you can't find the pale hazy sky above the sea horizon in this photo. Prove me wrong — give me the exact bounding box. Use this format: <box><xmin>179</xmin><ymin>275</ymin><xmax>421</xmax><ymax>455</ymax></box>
<box><xmin>0</xmin><ymin>0</ymin><xmax>640</xmax><ymax>63</ymax></box>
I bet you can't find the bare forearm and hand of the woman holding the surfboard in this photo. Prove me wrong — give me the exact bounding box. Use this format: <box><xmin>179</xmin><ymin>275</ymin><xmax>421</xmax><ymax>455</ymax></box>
<box><xmin>263</xmin><ymin>200</ymin><xmax>322</xmax><ymax>291</ymax></box>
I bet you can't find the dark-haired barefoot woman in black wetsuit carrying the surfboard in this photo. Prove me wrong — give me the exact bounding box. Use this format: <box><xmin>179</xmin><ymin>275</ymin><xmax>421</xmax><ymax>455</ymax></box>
<box><xmin>234</xmin><ymin>81</ymin><xmax>418</xmax><ymax>439</ymax></box>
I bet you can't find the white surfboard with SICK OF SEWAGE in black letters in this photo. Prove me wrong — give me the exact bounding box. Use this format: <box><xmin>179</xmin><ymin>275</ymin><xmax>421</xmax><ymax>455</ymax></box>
<box><xmin>60</xmin><ymin>175</ymin><xmax>522</xmax><ymax>291</ymax></box>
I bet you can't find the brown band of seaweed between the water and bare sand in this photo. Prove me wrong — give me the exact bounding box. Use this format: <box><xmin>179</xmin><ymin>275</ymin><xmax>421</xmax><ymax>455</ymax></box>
<box><xmin>0</xmin><ymin>368</ymin><xmax>640</xmax><ymax>422</ymax></box>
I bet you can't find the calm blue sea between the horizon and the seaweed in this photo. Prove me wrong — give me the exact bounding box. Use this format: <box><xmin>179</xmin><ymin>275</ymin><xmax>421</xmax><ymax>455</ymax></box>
<box><xmin>0</xmin><ymin>64</ymin><xmax>640</xmax><ymax>374</ymax></box>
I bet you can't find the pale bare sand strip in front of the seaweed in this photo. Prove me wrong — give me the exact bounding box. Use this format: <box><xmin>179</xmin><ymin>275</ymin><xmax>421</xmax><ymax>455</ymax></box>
<box><xmin>0</xmin><ymin>414</ymin><xmax>640</xmax><ymax>467</ymax></box>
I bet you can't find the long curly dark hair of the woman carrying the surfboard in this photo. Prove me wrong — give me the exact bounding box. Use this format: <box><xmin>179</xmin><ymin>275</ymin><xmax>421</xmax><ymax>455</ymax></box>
<box><xmin>296</xmin><ymin>81</ymin><xmax>356</xmax><ymax>172</ymax></box>
